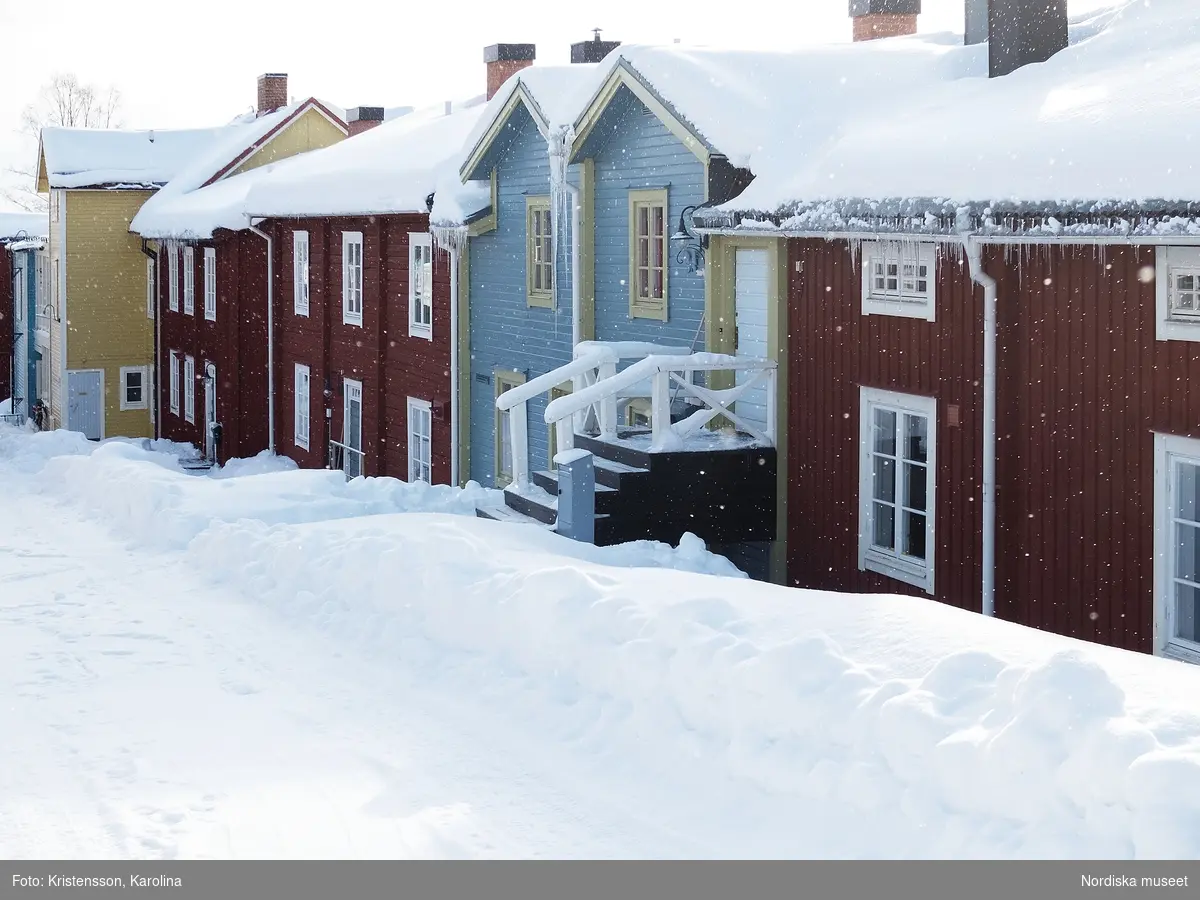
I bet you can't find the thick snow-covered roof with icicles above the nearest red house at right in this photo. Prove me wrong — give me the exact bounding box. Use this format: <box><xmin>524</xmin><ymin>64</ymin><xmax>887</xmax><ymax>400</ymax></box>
<box><xmin>700</xmin><ymin>0</ymin><xmax>1200</xmax><ymax>225</ymax></box>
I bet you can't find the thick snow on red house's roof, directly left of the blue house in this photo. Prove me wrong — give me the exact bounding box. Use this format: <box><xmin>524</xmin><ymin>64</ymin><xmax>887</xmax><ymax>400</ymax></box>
<box><xmin>246</xmin><ymin>97</ymin><xmax>487</xmax><ymax>217</ymax></box>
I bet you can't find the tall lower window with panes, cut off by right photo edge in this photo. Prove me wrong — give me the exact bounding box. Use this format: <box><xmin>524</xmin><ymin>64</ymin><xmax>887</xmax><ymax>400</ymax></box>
<box><xmin>1154</xmin><ymin>434</ymin><xmax>1200</xmax><ymax>662</ymax></box>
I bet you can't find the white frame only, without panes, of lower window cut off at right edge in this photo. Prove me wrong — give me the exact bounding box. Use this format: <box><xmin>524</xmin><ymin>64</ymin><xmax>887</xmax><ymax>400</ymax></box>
<box><xmin>1154</xmin><ymin>434</ymin><xmax>1200</xmax><ymax>662</ymax></box>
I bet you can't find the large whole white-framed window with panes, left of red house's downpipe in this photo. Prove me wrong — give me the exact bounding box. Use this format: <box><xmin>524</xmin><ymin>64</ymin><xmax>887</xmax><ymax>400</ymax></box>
<box><xmin>858</xmin><ymin>388</ymin><xmax>937</xmax><ymax>593</ymax></box>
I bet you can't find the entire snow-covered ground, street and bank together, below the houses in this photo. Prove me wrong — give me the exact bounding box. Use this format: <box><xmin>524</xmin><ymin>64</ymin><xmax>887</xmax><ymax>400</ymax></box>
<box><xmin>0</xmin><ymin>426</ymin><xmax>1200</xmax><ymax>858</ymax></box>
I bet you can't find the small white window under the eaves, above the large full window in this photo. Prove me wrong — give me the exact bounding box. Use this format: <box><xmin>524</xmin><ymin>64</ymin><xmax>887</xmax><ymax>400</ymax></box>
<box><xmin>863</xmin><ymin>241</ymin><xmax>937</xmax><ymax>322</ymax></box>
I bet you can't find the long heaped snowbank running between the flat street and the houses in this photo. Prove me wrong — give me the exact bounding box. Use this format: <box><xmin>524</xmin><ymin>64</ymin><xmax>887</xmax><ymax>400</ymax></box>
<box><xmin>0</xmin><ymin>430</ymin><xmax>1200</xmax><ymax>858</ymax></box>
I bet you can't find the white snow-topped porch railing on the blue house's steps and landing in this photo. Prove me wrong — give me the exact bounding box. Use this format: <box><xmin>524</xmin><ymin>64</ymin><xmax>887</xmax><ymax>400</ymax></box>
<box><xmin>496</xmin><ymin>342</ymin><xmax>778</xmax><ymax>491</ymax></box>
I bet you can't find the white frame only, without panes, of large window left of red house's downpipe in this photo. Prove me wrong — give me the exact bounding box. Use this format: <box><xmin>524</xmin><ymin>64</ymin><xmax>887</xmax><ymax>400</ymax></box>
<box><xmin>858</xmin><ymin>388</ymin><xmax>937</xmax><ymax>594</ymax></box>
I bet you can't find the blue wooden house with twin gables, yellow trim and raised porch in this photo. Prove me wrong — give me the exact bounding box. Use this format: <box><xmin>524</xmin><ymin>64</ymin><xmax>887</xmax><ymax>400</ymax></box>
<box><xmin>461</xmin><ymin>40</ymin><xmax>786</xmax><ymax>575</ymax></box>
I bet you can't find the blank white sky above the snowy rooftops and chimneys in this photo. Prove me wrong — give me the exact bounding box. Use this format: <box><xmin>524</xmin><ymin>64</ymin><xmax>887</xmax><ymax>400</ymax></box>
<box><xmin>0</xmin><ymin>0</ymin><xmax>1114</xmax><ymax>209</ymax></box>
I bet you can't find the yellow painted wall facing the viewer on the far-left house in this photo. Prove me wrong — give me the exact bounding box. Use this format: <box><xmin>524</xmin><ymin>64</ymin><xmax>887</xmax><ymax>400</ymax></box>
<box><xmin>60</xmin><ymin>191</ymin><xmax>154</xmax><ymax>438</ymax></box>
